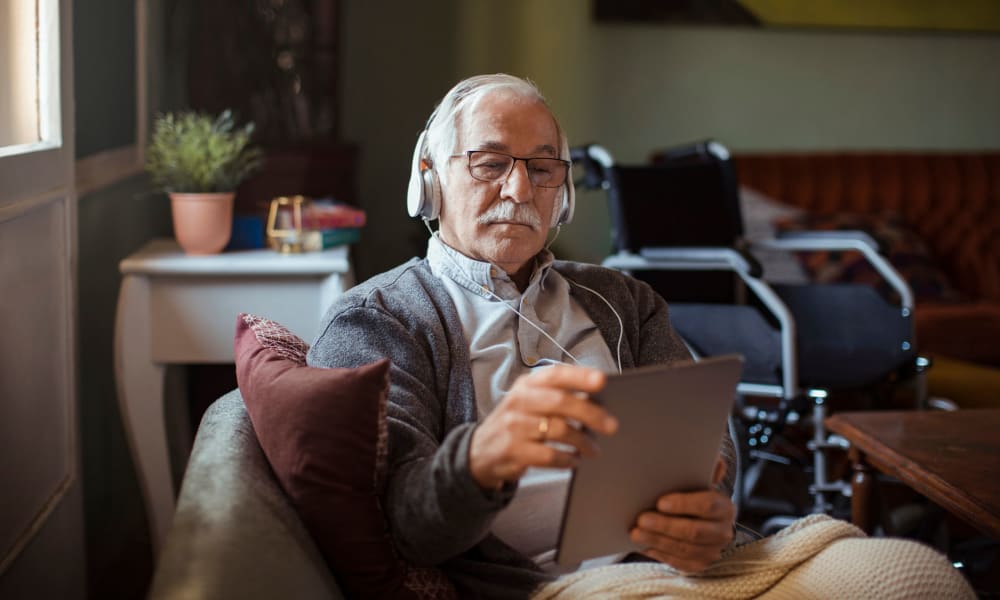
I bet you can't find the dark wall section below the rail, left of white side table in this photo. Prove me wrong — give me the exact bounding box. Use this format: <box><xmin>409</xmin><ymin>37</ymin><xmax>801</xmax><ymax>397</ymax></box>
<box><xmin>77</xmin><ymin>176</ymin><xmax>170</xmax><ymax>598</ymax></box>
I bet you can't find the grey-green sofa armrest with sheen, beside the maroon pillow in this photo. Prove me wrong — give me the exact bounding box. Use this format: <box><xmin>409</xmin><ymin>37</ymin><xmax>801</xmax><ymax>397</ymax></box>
<box><xmin>149</xmin><ymin>390</ymin><xmax>343</xmax><ymax>599</ymax></box>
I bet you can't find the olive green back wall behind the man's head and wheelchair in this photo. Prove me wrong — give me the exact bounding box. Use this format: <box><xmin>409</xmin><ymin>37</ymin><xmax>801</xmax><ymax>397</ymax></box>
<box><xmin>341</xmin><ymin>0</ymin><xmax>1000</xmax><ymax>276</ymax></box>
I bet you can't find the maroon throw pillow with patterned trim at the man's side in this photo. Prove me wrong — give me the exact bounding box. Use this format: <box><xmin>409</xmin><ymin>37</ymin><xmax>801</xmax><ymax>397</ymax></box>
<box><xmin>234</xmin><ymin>314</ymin><xmax>455</xmax><ymax>598</ymax></box>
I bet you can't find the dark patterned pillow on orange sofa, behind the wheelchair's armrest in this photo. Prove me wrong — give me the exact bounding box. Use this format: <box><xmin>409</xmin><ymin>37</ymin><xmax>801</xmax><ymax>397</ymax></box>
<box><xmin>775</xmin><ymin>213</ymin><xmax>960</xmax><ymax>302</ymax></box>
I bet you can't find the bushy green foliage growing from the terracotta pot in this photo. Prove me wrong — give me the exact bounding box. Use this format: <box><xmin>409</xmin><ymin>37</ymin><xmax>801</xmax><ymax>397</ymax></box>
<box><xmin>146</xmin><ymin>110</ymin><xmax>261</xmax><ymax>193</ymax></box>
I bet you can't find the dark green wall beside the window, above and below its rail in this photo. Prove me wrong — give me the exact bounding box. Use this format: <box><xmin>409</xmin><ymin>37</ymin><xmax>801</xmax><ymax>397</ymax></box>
<box><xmin>73</xmin><ymin>0</ymin><xmax>174</xmax><ymax>598</ymax></box>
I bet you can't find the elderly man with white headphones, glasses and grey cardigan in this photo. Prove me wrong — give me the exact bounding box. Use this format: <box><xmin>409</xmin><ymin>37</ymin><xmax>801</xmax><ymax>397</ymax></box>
<box><xmin>309</xmin><ymin>75</ymin><xmax>735</xmax><ymax>597</ymax></box>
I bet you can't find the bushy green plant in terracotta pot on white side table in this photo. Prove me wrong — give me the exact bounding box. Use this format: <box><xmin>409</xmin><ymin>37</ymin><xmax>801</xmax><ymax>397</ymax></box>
<box><xmin>146</xmin><ymin>110</ymin><xmax>261</xmax><ymax>254</ymax></box>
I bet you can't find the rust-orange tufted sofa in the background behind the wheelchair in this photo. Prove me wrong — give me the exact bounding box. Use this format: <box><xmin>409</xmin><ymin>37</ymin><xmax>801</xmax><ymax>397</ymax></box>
<box><xmin>734</xmin><ymin>151</ymin><xmax>1000</xmax><ymax>407</ymax></box>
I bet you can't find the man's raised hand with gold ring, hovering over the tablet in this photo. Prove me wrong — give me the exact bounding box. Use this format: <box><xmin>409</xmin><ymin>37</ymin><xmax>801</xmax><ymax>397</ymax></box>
<box><xmin>469</xmin><ymin>365</ymin><xmax>618</xmax><ymax>489</ymax></box>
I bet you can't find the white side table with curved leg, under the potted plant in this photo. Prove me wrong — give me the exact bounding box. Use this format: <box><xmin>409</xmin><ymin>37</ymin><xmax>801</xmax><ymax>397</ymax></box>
<box><xmin>114</xmin><ymin>239</ymin><xmax>354</xmax><ymax>554</ymax></box>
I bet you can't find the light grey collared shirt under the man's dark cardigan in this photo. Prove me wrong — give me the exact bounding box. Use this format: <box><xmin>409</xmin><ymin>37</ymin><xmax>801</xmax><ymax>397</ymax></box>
<box><xmin>427</xmin><ymin>236</ymin><xmax>618</xmax><ymax>566</ymax></box>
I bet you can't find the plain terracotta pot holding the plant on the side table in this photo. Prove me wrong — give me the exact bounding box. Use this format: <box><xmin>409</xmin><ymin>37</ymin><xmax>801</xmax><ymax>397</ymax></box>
<box><xmin>170</xmin><ymin>192</ymin><xmax>236</xmax><ymax>254</ymax></box>
